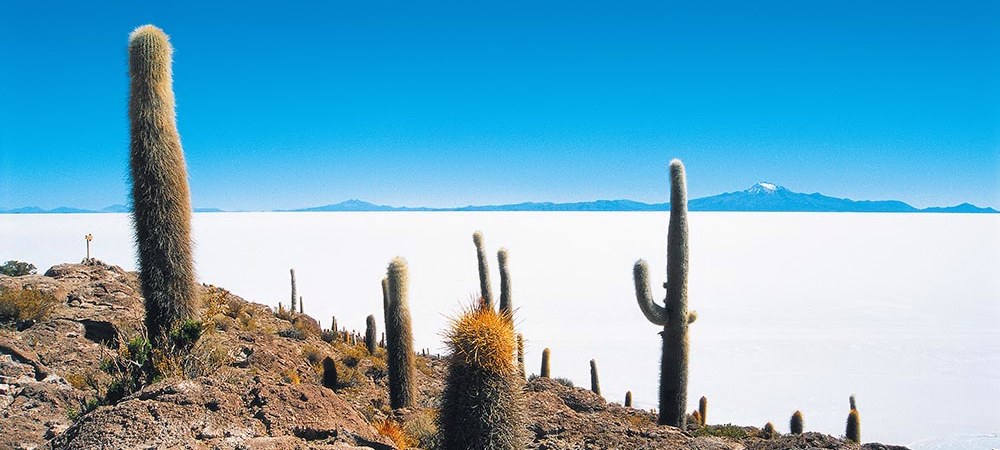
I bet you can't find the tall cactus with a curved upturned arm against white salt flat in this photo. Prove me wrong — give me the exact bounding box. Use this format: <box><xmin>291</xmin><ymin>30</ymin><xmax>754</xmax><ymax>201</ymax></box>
<box><xmin>633</xmin><ymin>159</ymin><xmax>695</xmax><ymax>429</ymax></box>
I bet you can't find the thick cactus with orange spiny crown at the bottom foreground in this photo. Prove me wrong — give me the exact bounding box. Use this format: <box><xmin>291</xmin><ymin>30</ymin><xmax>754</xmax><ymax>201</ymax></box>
<box><xmin>438</xmin><ymin>307</ymin><xmax>525</xmax><ymax>450</ymax></box>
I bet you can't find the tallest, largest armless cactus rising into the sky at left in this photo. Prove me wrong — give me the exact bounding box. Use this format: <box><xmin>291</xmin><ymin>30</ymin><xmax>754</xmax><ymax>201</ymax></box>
<box><xmin>128</xmin><ymin>25</ymin><xmax>197</xmax><ymax>348</ymax></box>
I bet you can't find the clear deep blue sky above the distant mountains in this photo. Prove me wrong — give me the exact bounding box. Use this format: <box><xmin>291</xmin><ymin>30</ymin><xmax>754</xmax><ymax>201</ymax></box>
<box><xmin>0</xmin><ymin>0</ymin><xmax>1000</xmax><ymax>210</ymax></box>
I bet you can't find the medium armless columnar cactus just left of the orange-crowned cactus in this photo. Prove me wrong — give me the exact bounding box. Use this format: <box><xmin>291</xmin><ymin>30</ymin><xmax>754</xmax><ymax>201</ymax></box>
<box><xmin>385</xmin><ymin>256</ymin><xmax>416</xmax><ymax>409</ymax></box>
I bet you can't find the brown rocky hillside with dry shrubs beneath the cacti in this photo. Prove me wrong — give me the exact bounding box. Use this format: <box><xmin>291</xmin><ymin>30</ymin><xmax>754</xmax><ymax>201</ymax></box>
<box><xmin>0</xmin><ymin>261</ymin><xmax>902</xmax><ymax>450</ymax></box>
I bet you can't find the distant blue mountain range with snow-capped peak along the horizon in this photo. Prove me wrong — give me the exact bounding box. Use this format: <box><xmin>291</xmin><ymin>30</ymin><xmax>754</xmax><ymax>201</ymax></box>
<box><xmin>0</xmin><ymin>182</ymin><xmax>998</xmax><ymax>214</ymax></box>
